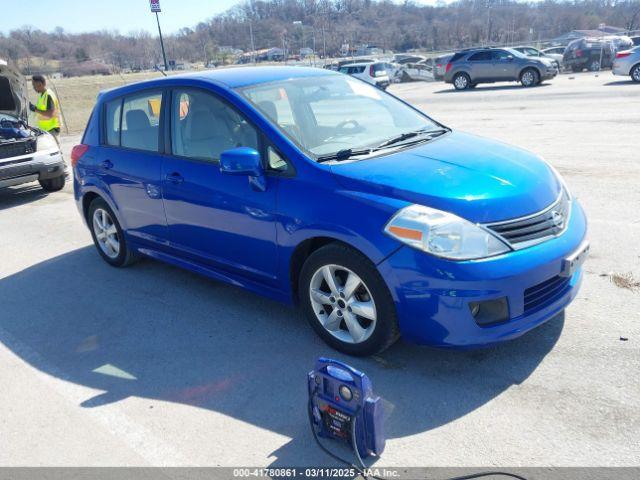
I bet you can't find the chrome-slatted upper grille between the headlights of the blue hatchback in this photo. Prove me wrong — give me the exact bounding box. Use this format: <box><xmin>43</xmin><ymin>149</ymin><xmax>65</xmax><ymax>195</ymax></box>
<box><xmin>485</xmin><ymin>191</ymin><xmax>571</xmax><ymax>248</ymax></box>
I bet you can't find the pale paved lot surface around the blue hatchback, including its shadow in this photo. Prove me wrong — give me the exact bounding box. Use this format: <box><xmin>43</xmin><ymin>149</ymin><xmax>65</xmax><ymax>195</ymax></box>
<box><xmin>0</xmin><ymin>72</ymin><xmax>640</xmax><ymax>466</ymax></box>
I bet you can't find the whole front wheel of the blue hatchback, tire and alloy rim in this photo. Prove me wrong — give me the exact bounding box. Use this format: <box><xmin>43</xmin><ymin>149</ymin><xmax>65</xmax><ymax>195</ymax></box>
<box><xmin>298</xmin><ymin>243</ymin><xmax>399</xmax><ymax>356</ymax></box>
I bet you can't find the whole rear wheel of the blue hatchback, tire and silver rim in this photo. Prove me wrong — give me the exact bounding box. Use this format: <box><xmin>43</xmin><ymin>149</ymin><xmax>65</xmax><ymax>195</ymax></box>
<box><xmin>87</xmin><ymin>198</ymin><xmax>136</xmax><ymax>267</ymax></box>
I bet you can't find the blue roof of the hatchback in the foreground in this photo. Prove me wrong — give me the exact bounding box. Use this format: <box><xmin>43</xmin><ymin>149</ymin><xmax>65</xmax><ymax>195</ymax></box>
<box><xmin>102</xmin><ymin>66</ymin><xmax>340</xmax><ymax>94</ymax></box>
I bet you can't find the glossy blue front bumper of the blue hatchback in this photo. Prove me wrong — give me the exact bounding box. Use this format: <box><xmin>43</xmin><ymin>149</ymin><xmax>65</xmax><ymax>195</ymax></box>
<box><xmin>378</xmin><ymin>200</ymin><xmax>587</xmax><ymax>348</ymax></box>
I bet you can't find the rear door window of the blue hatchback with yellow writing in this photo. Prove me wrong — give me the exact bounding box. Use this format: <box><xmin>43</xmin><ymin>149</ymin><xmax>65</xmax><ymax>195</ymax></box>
<box><xmin>120</xmin><ymin>91</ymin><xmax>162</xmax><ymax>152</ymax></box>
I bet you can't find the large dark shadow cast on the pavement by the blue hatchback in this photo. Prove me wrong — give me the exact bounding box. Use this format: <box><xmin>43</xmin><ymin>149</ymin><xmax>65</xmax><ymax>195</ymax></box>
<box><xmin>0</xmin><ymin>246</ymin><xmax>564</xmax><ymax>465</ymax></box>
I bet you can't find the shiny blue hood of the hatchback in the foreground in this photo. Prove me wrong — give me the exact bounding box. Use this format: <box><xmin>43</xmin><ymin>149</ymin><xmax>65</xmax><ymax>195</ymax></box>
<box><xmin>331</xmin><ymin>132</ymin><xmax>562</xmax><ymax>223</ymax></box>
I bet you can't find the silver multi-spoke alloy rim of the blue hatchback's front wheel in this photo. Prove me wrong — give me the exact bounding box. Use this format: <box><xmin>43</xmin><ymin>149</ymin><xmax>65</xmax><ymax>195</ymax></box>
<box><xmin>309</xmin><ymin>265</ymin><xmax>377</xmax><ymax>343</ymax></box>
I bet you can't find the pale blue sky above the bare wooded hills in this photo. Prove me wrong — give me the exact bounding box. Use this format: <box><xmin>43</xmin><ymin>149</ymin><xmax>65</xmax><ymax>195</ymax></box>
<box><xmin>0</xmin><ymin>0</ymin><xmax>436</xmax><ymax>34</ymax></box>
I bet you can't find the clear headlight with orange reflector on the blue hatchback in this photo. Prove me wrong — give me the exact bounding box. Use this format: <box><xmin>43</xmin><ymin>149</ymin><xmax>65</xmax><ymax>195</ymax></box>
<box><xmin>384</xmin><ymin>205</ymin><xmax>510</xmax><ymax>260</ymax></box>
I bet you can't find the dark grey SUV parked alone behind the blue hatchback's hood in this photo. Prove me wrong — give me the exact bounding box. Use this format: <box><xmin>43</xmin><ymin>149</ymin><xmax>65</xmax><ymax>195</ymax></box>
<box><xmin>444</xmin><ymin>48</ymin><xmax>558</xmax><ymax>90</ymax></box>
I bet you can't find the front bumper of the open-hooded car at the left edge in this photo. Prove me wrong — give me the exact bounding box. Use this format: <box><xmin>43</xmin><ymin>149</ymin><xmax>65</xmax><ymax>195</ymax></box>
<box><xmin>0</xmin><ymin>151</ymin><xmax>66</xmax><ymax>188</ymax></box>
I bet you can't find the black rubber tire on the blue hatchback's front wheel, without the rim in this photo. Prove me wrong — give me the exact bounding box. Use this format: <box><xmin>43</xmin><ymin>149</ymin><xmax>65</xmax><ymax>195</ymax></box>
<box><xmin>298</xmin><ymin>243</ymin><xmax>400</xmax><ymax>356</ymax></box>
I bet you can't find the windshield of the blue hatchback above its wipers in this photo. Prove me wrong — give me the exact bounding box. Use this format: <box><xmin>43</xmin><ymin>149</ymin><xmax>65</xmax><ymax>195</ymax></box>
<box><xmin>240</xmin><ymin>75</ymin><xmax>442</xmax><ymax>159</ymax></box>
